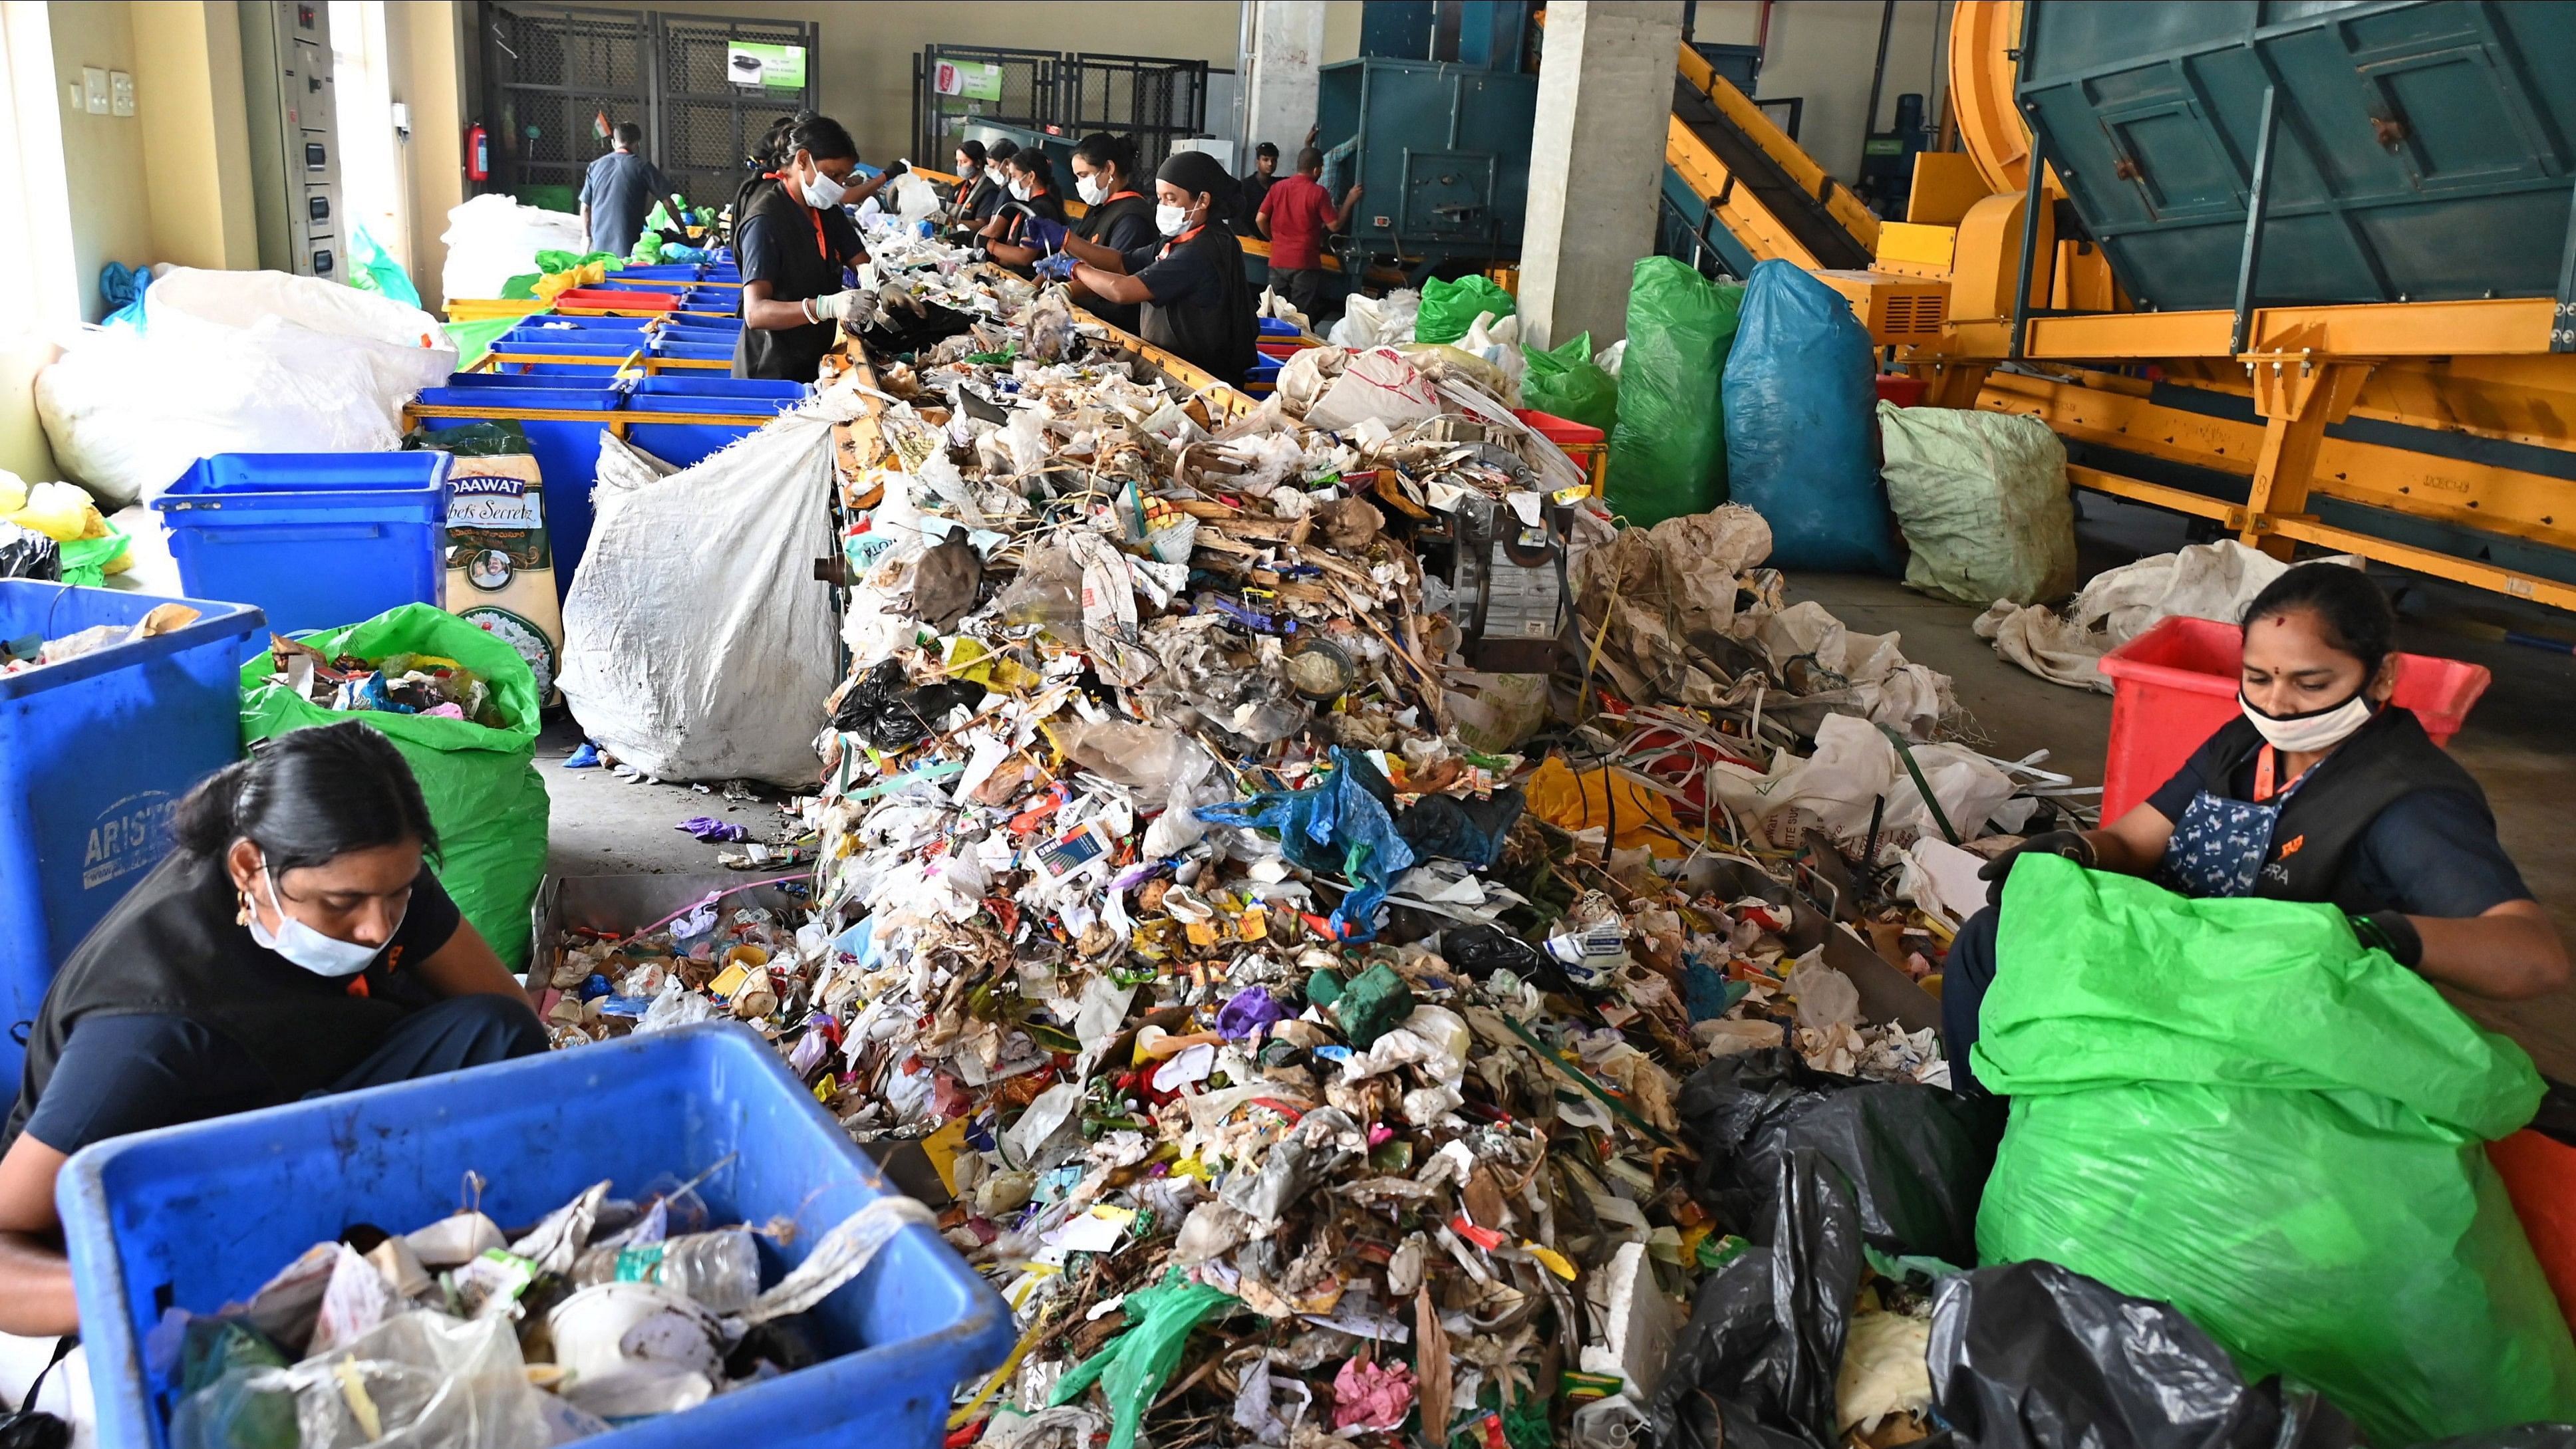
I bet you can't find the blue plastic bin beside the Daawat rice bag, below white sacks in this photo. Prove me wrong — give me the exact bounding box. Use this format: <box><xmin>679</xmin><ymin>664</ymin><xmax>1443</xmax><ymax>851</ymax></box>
<box><xmin>152</xmin><ymin>453</ymin><xmax>451</xmax><ymax>633</ymax></box>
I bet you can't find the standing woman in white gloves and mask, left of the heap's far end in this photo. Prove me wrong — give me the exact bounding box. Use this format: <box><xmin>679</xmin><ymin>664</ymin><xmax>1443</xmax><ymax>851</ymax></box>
<box><xmin>734</xmin><ymin>116</ymin><xmax>904</xmax><ymax>384</ymax></box>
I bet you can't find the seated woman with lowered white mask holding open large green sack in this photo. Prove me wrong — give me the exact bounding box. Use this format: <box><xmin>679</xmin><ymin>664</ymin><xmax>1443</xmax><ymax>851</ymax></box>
<box><xmin>1942</xmin><ymin>564</ymin><xmax>2568</xmax><ymax>1091</ymax></box>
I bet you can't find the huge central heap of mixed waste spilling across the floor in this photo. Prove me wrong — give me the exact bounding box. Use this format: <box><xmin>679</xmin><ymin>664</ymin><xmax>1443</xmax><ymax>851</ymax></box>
<box><xmin>517</xmin><ymin>223</ymin><xmax>2112</xmax><ymax>1449</ymax></box>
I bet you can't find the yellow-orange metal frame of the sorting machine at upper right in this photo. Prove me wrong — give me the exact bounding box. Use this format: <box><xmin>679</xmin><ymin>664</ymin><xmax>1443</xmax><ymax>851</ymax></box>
<box><xmin>1731</xmin><ymin>0</ymin><xmax>2576</xmax><ymax>607</ymax></box>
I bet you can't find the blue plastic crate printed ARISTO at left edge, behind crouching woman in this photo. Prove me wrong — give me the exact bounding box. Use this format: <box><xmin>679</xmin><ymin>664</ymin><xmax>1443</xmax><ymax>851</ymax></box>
<box><xmin>0</xmin><ymin>579</ymin><xmax>268</xmax><ymax>1094</ymax></box>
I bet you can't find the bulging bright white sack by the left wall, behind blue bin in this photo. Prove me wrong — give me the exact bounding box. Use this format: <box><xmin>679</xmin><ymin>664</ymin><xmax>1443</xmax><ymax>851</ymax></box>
<box><xmin>36</xmin><ymin>268</ymin><xmax>456</xmax><ymax>512</ymax></box>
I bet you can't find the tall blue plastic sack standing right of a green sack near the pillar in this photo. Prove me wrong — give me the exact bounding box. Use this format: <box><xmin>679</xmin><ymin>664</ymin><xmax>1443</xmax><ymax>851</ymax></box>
<box><xmin>1721</xmin><ymin>260</ymin><xmax>1904</xmax><ymax>574</ymax></box>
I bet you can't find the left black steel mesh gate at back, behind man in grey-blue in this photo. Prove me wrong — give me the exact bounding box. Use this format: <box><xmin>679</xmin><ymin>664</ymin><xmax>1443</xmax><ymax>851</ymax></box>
<box><xmin>482</xmin><ymin>3</ymin><xmax>819</xmax><ymax>211</ymax></box>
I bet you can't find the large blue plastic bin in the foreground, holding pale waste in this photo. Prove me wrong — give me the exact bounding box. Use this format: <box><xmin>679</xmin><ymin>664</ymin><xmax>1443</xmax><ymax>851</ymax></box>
<box><xmin>54</xmin><ymin>1022</ymin><xmax>1015</xmax><ymax>1449</ymax></box>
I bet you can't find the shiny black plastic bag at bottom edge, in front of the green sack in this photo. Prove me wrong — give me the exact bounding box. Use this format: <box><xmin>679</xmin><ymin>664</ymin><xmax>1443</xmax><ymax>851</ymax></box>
<box><xmin>1924</xmin><ymin>1261</ymin><xmax>2359</xmax><ymax>1449</ymax></box>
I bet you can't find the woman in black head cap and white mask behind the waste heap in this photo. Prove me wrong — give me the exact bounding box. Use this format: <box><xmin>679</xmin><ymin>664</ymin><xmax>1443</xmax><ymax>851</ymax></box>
<box><xmin>1072</xmin><ymin>152</ymin><xmax>1260</xmax><ymax>386</ymax></box>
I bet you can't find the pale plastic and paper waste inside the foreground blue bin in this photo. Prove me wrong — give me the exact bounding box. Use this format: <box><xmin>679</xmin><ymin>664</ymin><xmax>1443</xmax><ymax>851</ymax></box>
<box><xmin>147</xmin><ymin>1158</ymin><xmax>930</xmax><ymax>1449</ymax></box>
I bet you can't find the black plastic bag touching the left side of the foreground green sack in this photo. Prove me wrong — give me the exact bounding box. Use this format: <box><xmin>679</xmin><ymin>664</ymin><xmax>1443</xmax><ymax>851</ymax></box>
<box><xmin>1677</xmin><ymin>1047</ymin><xmax>2007</xmax><ymax>1263</ymax></box>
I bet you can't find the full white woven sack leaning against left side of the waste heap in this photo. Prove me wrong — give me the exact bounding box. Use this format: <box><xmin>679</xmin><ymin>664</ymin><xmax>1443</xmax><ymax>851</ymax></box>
<box><xmin>557</xmin><ymin>394</ymin><xmax>858</xmax><ymax>787</ymax></box>
